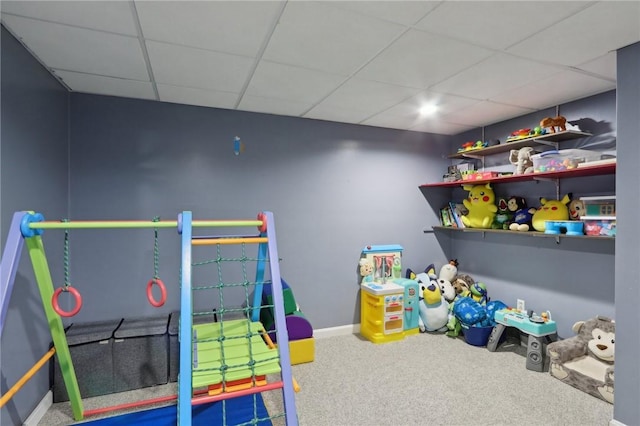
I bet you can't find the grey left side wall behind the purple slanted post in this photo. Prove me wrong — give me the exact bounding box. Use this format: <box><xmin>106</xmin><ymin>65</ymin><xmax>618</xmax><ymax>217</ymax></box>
<box><xmin>0</xmin><ymin>27</ymin><xmax>69</xmax><ymax>426</ymax></box>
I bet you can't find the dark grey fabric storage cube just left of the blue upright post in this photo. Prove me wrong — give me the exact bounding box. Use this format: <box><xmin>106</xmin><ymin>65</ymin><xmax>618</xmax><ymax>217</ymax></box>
<box><xmin>113</xmin><ymin>315</ymin><xmax>169</xmax><ymax>392</ymax></box>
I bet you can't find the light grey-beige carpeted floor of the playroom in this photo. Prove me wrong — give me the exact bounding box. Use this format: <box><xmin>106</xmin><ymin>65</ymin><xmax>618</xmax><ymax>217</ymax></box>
<box><xmin>39</xmin><ymin>334</ymin><xmax>613</xmax><ymax>426</ymax></box>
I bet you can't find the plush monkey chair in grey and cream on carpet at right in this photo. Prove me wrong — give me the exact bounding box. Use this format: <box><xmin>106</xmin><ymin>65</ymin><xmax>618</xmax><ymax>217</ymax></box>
<box><xmin>547</xmin><ymin>316</ymin><xmax>616</xmax><ymax>404</ymax></box>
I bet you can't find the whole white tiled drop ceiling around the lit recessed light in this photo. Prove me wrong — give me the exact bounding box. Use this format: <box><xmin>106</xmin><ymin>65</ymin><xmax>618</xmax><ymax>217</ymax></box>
<box><xmin>0</xmin><ymin>0</ymin><xmax>640</xmax><ymax>135</ymax></box>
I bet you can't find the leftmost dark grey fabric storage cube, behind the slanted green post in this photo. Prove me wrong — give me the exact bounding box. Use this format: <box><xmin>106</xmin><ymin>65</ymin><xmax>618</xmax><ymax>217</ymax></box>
<box><xmin>52</xmin><ymin>319</ymin><xmax>122</xmax><ymax>402</ymax></box>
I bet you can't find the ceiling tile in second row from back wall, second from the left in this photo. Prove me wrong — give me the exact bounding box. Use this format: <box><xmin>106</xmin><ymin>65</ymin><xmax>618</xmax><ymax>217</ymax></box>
<box><xmin>146</xmin><ymin>41</ymin><xmax>254</xmax><ymax>93</ymax></box>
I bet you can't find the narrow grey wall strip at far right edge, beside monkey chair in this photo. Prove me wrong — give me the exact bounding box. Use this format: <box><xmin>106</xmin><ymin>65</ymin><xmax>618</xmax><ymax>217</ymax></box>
<box><xmin>614</xmin><ymin>43</ymin><xmax>640</xmax><ymax>425</ymax></box>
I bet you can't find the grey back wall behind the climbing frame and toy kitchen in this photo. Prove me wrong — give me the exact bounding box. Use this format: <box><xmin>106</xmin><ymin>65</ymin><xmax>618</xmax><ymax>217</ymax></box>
<box><xmin>66</xmin><ymin>94</ymin><xmax>449</xmax><ymax>328</ymax></box>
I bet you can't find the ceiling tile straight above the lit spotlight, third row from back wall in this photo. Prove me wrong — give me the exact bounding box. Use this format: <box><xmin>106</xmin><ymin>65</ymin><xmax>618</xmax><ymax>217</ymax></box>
<box><xmin>356</xmin><ymin>30</ymin><xmax>493</xmax><ymax>89</ymax></box>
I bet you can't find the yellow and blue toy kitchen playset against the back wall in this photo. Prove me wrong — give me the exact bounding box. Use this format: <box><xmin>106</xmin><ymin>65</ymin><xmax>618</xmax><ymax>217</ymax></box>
<box><xmin>358</xmin><ymin>244</ymin><xmax>420</xmax><ymax>343</ymax></box>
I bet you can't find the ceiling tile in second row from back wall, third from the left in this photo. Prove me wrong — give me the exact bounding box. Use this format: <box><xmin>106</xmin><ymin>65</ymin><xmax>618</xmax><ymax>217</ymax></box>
<box><xmin>246</xmin><ymin>61</ymin><xmax>344</xmax><ymax>104</ymax></box>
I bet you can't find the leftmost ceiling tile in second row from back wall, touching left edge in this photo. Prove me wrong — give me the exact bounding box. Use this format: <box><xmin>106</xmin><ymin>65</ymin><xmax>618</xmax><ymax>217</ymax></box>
<box><xmin>3</xmin><ymin>15</ymin><xmax>149</xmax><ymax>81</ymax></box>
